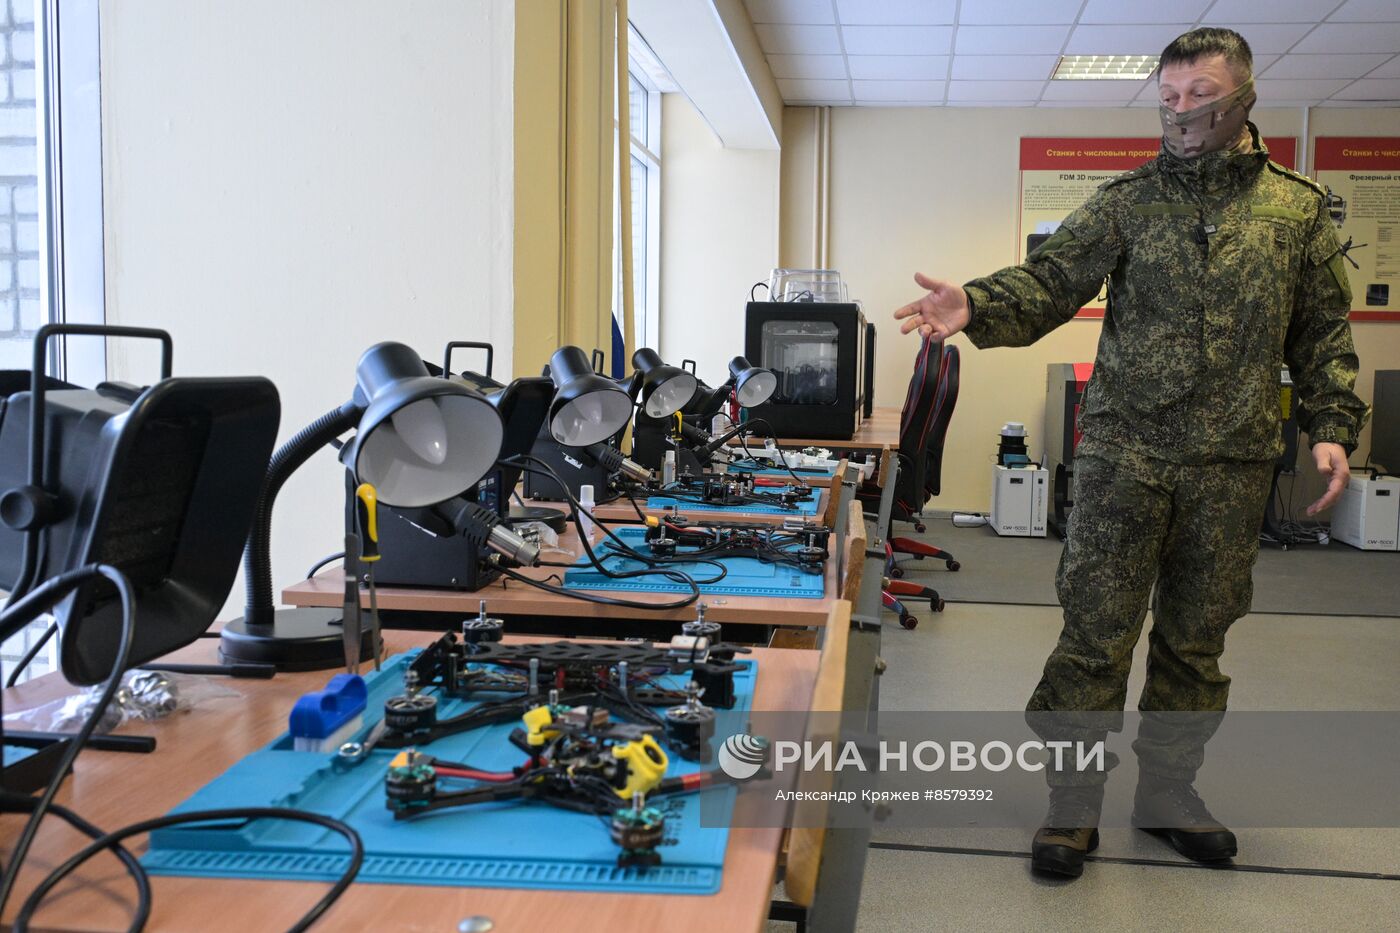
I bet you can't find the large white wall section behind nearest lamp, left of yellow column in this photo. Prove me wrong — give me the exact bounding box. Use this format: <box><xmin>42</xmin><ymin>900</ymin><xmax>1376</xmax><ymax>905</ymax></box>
<box><xmin>102</xmin><ymin>0</ymin><xmax>514</xmax><ymax>618</ymax></box>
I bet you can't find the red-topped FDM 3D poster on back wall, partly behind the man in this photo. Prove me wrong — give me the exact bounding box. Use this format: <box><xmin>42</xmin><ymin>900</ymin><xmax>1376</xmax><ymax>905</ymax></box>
<box><xmin>1015</xmin><ymin>136</ymin><xmax>1298</xmax><ymax>318</ymax></box>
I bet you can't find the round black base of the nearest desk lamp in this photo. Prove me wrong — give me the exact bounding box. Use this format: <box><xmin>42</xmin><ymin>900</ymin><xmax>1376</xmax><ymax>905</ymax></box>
<box><xmin>218</xmin><ymin>608</ymin><xmax>374</xmax><ymax>671</ymax></box>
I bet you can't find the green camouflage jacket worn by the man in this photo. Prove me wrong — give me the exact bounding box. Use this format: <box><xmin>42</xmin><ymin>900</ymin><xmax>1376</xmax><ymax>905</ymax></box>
<box><xmin>966</xmin><ymin>125</ymin><xmax>1368</xmax><ymax>464</ymax></box>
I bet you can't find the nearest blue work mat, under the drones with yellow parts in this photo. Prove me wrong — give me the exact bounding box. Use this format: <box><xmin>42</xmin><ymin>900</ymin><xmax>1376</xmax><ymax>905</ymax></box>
<box><xmin>141</xmin><ymin>651</ymin><xmax>756</xmax><ymax>894</ymax></box>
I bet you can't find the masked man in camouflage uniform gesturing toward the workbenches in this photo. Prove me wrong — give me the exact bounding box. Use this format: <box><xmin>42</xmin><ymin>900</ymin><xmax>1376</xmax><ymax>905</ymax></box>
<box><xmin>895</xmin><ymin>28</ymin><xmax>1366</xmax><ymax>877</ymax></box>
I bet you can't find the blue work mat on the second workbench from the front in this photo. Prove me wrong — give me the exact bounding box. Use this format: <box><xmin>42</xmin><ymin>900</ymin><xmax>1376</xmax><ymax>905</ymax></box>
<box><xmin>564</xmin><ymin>525</ymin><xmax>826</xmax><ymax>600</ymax></box>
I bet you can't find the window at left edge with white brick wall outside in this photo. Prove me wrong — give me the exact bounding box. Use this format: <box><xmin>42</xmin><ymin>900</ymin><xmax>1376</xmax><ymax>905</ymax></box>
<box><xmin>0</xmin><ymin>0</ymin><xmax>106</xmax><ymax>679</ymax></box>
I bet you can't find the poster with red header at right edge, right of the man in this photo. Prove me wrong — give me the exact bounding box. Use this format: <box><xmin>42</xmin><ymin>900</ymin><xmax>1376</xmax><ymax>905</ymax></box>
<box><xmin>1313</xmin><ymin>136</ymin><xmax>1400</xmax><ymax>321</ymax></box>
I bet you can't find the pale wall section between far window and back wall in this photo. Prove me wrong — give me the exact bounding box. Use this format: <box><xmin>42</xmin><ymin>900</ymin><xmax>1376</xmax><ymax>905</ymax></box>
<box><xmin>659</xmin><ymin>94</ymin><xmax>781</xmax><ymax>385</ymax></box>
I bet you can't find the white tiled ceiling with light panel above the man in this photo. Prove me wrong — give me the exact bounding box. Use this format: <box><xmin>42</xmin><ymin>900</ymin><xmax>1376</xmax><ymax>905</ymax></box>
<box><xmin>743</xmin><ymin>0</ymin><xmax>1400</xmax><ymax>106</ymax></box>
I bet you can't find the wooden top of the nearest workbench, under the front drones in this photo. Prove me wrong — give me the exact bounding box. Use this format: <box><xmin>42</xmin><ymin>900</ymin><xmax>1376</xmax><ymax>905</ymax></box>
<box><xmin>0</xmin><ymin>632</ymin><xmax>818</xmax><ymax>933</ymax></box>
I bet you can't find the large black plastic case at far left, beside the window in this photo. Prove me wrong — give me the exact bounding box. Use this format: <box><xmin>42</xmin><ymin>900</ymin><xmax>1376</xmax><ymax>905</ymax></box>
<box><xmin>0</xmin><ymin>371</ymin><xmax>281</xmax><ymax>685</ymax></box>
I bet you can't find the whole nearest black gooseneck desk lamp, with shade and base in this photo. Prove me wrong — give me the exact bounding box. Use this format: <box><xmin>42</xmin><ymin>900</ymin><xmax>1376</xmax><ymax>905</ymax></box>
<box><xmin>220</xmin><ymin>343</ymin><xmax>503</xmax><ymax>671</ymax></box>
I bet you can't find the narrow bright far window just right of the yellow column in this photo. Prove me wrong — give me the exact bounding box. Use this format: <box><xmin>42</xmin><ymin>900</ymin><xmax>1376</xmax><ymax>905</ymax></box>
<box><xmin>613</xmin><ymin>39</ymin><xmax>661</xmax><ymax>355</ymax></box>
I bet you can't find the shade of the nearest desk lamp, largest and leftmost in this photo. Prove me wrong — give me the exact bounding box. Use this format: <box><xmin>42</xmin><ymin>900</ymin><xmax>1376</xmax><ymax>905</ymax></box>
<box><xmin>346</xmin><ymin>343</ymin><xmax>504</xmax><ymax>509</ymax></box>
